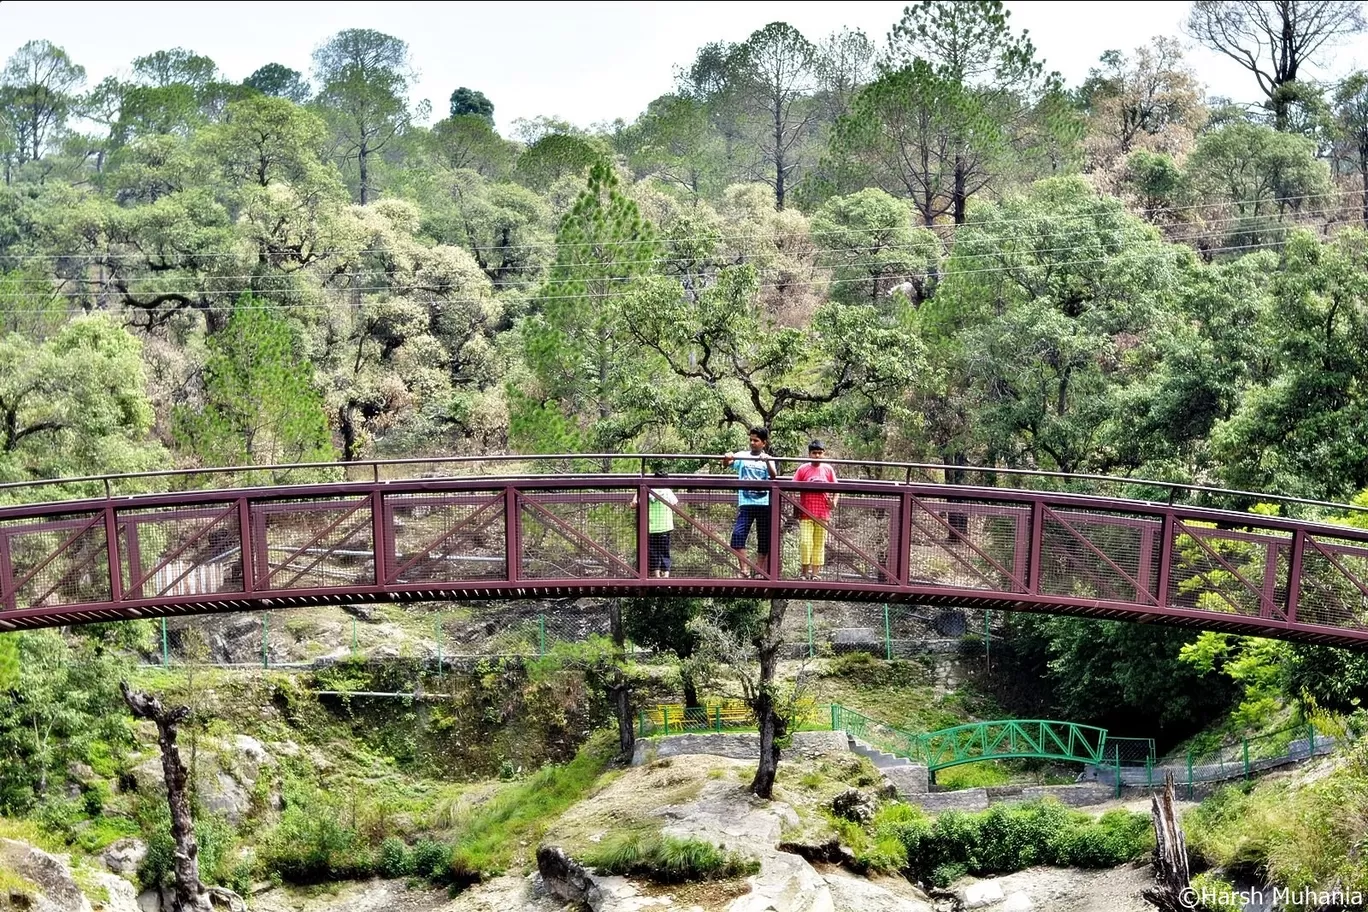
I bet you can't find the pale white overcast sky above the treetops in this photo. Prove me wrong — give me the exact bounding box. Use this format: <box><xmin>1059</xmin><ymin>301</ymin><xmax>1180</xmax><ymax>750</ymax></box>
<box><xmin>0</xmin><ymin>0</ymin><xmax>1368</xmax><ymax>135</ymax></box>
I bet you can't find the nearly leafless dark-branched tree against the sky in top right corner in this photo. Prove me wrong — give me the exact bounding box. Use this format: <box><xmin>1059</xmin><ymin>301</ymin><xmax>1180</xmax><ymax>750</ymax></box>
<box><xmin>1187</xmin><ymin>0</ymin><xmax>1365</xmax><ymax>130</ymax></box>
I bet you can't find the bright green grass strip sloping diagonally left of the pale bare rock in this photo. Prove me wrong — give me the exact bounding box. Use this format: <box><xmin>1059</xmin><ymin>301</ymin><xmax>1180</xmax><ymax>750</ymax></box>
<box><xmin>450</xmin><ymin>732</ymin><xmax>617</xmax><ymax>883</ymax></box>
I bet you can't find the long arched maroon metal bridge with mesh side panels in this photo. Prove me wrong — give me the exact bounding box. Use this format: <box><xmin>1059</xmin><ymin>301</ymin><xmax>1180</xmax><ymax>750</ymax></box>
<box><xmin>0</xmin><ymin>457</ymin><xmax>1368</xmax><ymax>647</ymax></box>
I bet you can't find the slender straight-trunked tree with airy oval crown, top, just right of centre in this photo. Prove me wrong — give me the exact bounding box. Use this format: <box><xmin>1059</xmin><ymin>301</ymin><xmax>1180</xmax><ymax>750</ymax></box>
<box><xmin>731</xmin><ymin>22</ymin><xmax>819</xmax><ymax>209</ymax></box>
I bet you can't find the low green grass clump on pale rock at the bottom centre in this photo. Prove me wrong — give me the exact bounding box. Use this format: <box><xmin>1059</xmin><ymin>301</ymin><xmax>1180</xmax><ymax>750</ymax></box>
<box><xmin>584</xmin><ymin>831</ymin><xmax>761</xmax><ymax>883</ymax></box>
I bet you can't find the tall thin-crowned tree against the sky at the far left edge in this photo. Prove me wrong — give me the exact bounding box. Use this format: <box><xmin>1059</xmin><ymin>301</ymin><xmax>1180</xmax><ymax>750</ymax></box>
<box><xmin>0</xmin><ymin>41</ymin><xmax>85</xmax><ymax>164</ymax></box>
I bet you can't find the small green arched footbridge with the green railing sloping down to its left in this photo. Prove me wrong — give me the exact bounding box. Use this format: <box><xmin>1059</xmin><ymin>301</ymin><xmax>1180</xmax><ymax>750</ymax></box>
<box><xmin>832</xmin><ymin>704</ymin><xmax>1108</xmax><ymax>773</ymax></box>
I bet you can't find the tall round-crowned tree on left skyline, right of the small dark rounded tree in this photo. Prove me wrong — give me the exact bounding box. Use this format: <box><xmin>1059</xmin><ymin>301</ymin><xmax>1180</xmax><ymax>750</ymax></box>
<box><xmin>313</xmin><ymin>29</ymin><xmax>412</xmax><ymax>205</ymax></box>
